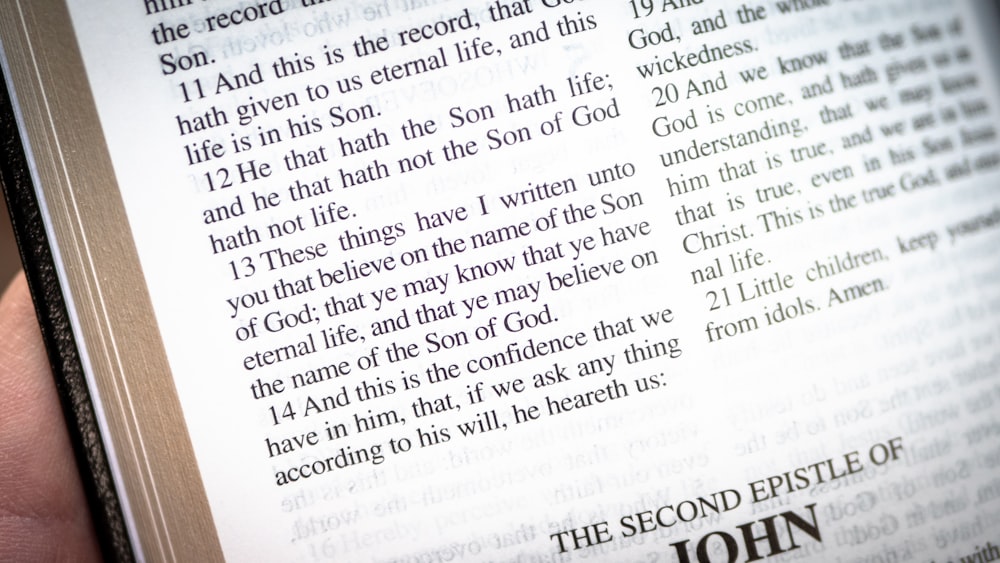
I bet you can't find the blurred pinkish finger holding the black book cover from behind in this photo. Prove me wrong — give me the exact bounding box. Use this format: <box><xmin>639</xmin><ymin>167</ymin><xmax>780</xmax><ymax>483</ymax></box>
<box><xmin>0</xmin><ymin>274</ymin><xmax>99</xmax><ymax>561</ymax></box>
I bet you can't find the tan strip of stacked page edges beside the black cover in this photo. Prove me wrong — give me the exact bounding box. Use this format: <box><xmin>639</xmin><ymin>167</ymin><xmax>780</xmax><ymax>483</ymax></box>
<box><xmin>0</xmin><ymin>0</ymin><xmax>222</xmax><ymax>561</ymax></box>
